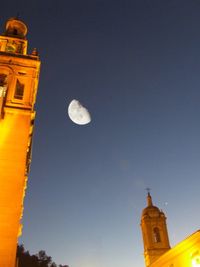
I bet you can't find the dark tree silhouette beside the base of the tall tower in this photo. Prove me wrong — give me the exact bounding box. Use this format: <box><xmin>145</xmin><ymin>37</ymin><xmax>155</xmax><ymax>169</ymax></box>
<box><xmin>17</xmin><ymin>245</ymin><xmax>69</xmax><ymax>267</ymax></box>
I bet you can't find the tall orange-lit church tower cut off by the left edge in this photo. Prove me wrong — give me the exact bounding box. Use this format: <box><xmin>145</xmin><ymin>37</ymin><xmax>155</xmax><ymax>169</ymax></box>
<box><xmin>0</xmin><ymin>18</ymin><xmax>40</xmax><ymax>267</ymax></box>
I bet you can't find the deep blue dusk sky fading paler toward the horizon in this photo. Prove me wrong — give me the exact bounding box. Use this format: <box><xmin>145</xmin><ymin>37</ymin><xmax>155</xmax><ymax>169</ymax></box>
<box><xmin>0</xmin><ymin>0</ymin><xmax>200</xmax><ymax>267</ymax></box>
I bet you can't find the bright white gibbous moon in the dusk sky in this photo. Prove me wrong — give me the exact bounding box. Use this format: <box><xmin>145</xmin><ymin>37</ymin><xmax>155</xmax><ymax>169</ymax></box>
<box><xmin>68</xmin><ymin>99</ymin><xmax>91</xmax><ymax>125</ymax></box>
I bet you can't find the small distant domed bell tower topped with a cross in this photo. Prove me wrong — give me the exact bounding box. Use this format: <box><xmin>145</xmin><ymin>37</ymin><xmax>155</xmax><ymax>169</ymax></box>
<box><xmin>141</xmin><ymin>192</ymin><xmax>170</xmax><ymax>267</ymax></box>
